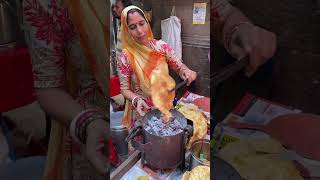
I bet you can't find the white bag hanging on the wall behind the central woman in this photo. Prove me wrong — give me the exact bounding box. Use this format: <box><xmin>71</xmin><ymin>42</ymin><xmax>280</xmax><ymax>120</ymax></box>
<box><xmin>161</xmin><ymin>6</ymin><xmax>182</xmax><ymax>60</ymax></box>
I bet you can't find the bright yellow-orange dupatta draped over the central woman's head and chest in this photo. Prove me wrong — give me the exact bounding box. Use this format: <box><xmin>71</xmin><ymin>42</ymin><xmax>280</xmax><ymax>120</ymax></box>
<box><xmin>121</xmin><ymin>6</ymin><xmax>166</xmax><ymax>128</ymax></box>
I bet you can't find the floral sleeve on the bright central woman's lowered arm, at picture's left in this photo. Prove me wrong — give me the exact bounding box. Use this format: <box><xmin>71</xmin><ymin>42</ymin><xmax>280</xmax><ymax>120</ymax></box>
<box><xmin>117</xmin><ymin>52</ymin><xmax>132</xmax><ymax>90</ymax></box>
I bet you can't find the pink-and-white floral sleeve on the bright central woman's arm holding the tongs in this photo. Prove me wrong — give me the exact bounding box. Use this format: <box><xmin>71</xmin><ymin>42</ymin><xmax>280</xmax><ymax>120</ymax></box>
<box><xmin>158</xmin><ymin>40</ymin><xmax>183</xmax><ymax>72</ymax></box>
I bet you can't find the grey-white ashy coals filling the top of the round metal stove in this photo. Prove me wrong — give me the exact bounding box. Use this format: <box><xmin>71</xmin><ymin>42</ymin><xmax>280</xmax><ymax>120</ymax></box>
<box><xmin>145</xmin><ymin>117</ymin><xmax>183</xmax><ymax>136</ymax></box>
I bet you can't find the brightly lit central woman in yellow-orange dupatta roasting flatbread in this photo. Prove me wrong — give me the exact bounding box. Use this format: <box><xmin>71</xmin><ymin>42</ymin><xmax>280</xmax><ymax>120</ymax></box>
<box><xmin>117</xmin><ymin>6</ymin><xmax>196</xmax><ymax>128</ymax></box>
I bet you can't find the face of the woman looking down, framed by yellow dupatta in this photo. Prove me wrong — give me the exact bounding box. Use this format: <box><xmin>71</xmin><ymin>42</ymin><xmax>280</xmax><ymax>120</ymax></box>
<box><xmin>128</xmin><ymin>12</ymin><xmax>149</xmax><ymax>45</ymax></box>
